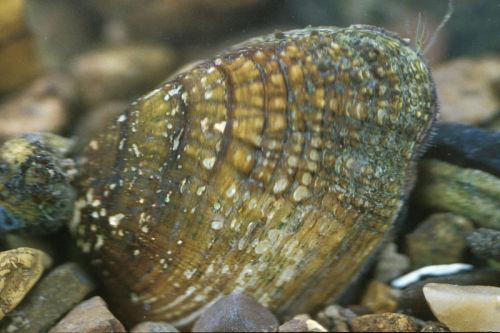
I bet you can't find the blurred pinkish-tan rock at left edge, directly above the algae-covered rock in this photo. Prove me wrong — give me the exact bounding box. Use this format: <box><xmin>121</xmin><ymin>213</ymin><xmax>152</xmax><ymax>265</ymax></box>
<box><xmin>0</xmin><ymin>74</ymin><xmax>76</xmax><ymax>142</ymax></box>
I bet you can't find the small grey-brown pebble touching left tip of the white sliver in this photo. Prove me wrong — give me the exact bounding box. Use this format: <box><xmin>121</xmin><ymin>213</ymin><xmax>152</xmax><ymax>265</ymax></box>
<box><xmin>374</xmin><ymin>242</ymin><xmax>410</xmax><ymax>283</ymax></box>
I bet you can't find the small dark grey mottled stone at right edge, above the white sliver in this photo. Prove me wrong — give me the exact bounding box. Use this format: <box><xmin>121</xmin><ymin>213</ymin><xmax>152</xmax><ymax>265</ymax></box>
<box><xmin>467</xmin><ymin>228</ymin><xmax>500</xmax><ymax>260</ymax></box>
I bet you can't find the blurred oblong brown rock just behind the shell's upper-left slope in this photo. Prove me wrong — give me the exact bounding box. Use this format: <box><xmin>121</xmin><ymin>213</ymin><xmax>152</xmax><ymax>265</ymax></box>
<box><xmin>70</xmin><ymin>44</ymin><xmax>176</xmax><ymax>104</ymax></box>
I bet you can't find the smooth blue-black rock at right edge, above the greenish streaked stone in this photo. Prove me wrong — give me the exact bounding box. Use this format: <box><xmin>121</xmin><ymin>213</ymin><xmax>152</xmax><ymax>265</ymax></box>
<box><xmin>426</xmin><ymin>123</ymin><xmax>500</xmax><ymax>176</ymax></box>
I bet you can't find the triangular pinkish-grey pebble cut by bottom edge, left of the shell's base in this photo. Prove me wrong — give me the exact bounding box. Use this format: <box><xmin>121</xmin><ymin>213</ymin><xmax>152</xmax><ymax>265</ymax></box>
<box><xmin>49</xmin><ymin>296</ymin><xmax>124</xmax><ymax>333</ymax></box>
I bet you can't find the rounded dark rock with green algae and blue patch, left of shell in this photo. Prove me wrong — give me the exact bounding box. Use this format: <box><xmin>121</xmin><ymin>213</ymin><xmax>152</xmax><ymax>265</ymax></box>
<box><xmin>0</xmin><ymin>133</ymin><xmax>75</xmax><ymax>234</ymax></box>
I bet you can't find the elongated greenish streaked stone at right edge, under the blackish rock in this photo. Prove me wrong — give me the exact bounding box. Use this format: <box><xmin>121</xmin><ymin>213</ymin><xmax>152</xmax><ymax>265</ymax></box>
<box><xmin>415</xmin><ymin>159</ymin><xmax>500</xmax><ymax>230</ymax></box>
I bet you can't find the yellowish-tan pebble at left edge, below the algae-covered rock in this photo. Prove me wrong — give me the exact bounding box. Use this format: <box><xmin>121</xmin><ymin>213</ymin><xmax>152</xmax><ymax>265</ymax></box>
<box><xmin>0</xmin><ymin>247</ymin><xmax>52</xmax><ymax>319</ymax></box>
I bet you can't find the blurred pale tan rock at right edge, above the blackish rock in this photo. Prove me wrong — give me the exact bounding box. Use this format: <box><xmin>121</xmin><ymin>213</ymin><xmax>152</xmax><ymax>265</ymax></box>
<box><xmin>432</xmin><ymin>57</ymin><xmax>500</xmax><ymax>124</ymax></box>
